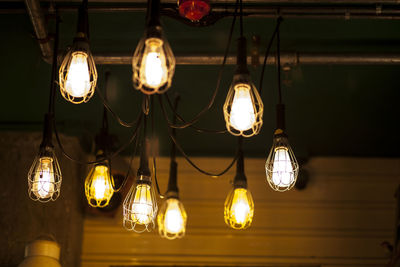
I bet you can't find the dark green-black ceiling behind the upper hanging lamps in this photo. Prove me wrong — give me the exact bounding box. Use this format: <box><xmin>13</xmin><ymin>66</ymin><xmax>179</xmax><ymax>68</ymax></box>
<box><xmin>0</xmin><ymin>1</ymin><xmax>400</xmax><ymax>161</ymax></box>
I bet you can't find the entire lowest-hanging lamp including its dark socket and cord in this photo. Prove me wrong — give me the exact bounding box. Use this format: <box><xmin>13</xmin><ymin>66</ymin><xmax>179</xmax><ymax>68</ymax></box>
<box><xmin>157</xmin><ymin>98</ymin><xmax>187</xmax><ymax>239</ymax></box>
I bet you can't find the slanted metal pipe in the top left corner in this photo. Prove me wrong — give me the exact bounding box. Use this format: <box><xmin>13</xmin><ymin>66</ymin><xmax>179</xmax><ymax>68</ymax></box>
<box><xmin>25</xmin><ymin>0</ymin><xmax>53</xmax><ymax>63</ymax></box>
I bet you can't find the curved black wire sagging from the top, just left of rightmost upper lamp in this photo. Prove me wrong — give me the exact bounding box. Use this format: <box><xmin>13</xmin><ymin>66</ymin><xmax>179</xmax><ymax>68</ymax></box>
<box><xmin>161</xmin><ymin>0</ymin><xmax>240</xmax><ymax>129</ymax></box>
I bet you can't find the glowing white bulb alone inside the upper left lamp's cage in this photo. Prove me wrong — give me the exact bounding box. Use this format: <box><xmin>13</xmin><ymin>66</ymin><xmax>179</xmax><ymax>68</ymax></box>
<box><xmin>65</xmin><ymin>52</ymin><xmax>91</xmax><ymax>97</ymax></box>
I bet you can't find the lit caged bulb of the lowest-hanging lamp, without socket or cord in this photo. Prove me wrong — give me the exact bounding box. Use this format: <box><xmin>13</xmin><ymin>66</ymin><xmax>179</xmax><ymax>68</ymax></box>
<box><xmin>157</xmin><ymin>197</ymin><xmax>187</xmax><ymax>239</ymax></box>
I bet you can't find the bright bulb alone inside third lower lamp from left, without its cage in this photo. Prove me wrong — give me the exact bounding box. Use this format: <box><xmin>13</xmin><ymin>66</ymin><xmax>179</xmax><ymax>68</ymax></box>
<box><xmin>132</xmin><ymin>184</ymin><xmax>154</xmax><ymax>224</ymax></box>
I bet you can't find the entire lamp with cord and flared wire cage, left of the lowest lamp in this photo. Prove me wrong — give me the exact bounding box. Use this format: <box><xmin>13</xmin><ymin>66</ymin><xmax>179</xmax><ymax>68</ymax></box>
<box><xmin>123</xmin><ymin>115</ymin><xmax>158</xmax><ymax>233</ymax></box>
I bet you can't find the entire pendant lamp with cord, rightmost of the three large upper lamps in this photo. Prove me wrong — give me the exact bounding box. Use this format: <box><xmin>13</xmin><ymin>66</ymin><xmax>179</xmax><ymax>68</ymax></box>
<box><xmin>223</xmin><ymin>1</ymin><xmax>264</xmax><ymax>137</ymax></box>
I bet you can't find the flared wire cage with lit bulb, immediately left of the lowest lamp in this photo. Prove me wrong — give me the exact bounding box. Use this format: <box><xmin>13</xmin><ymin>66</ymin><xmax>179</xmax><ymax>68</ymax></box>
<box><xmin>123</xmin><ymin>175</ymin><xmax>158</xmax><ymax>233</ymax></box>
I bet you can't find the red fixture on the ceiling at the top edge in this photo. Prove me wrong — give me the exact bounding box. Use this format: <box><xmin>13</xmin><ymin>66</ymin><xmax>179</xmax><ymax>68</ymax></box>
<box><xmin>178</xmin><ymin>0</ymin><xmax>210</xmax><ymax>21</ymax></box>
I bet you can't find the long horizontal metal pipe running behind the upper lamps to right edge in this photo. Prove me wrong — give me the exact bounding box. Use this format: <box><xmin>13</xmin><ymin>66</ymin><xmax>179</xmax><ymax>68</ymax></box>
<box><xmin>94</xmin><ymin>52</ymin><xmax>400</xmax><ymax>66</ymax></box>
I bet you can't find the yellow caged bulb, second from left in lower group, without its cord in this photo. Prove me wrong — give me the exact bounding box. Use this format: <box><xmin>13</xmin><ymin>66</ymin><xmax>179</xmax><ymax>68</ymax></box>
<box><xmin>85</xmin><ymin>164</ymin><xmax>114</xmax><ymax>208</ymax></box>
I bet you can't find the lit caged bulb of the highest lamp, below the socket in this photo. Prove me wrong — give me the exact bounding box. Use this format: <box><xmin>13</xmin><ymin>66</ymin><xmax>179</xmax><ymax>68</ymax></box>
<box><xmin>132</xmin><ymin>34</ymin><xmax>175</xmax><ymax>94</ymax></box>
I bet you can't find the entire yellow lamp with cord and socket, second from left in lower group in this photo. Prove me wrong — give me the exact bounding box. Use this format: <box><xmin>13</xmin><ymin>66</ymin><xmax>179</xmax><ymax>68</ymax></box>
<box><xmin>85</xmin><ymin>72</ymin><xmax>114</xmax><ymax>208</ymax></box>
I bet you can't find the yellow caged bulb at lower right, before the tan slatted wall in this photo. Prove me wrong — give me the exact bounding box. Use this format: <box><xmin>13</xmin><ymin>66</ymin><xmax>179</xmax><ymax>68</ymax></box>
<box><xmin>225</xmin><ymin>188</ymin><xmax>254</xmax><ymax>229</ymax></box>
